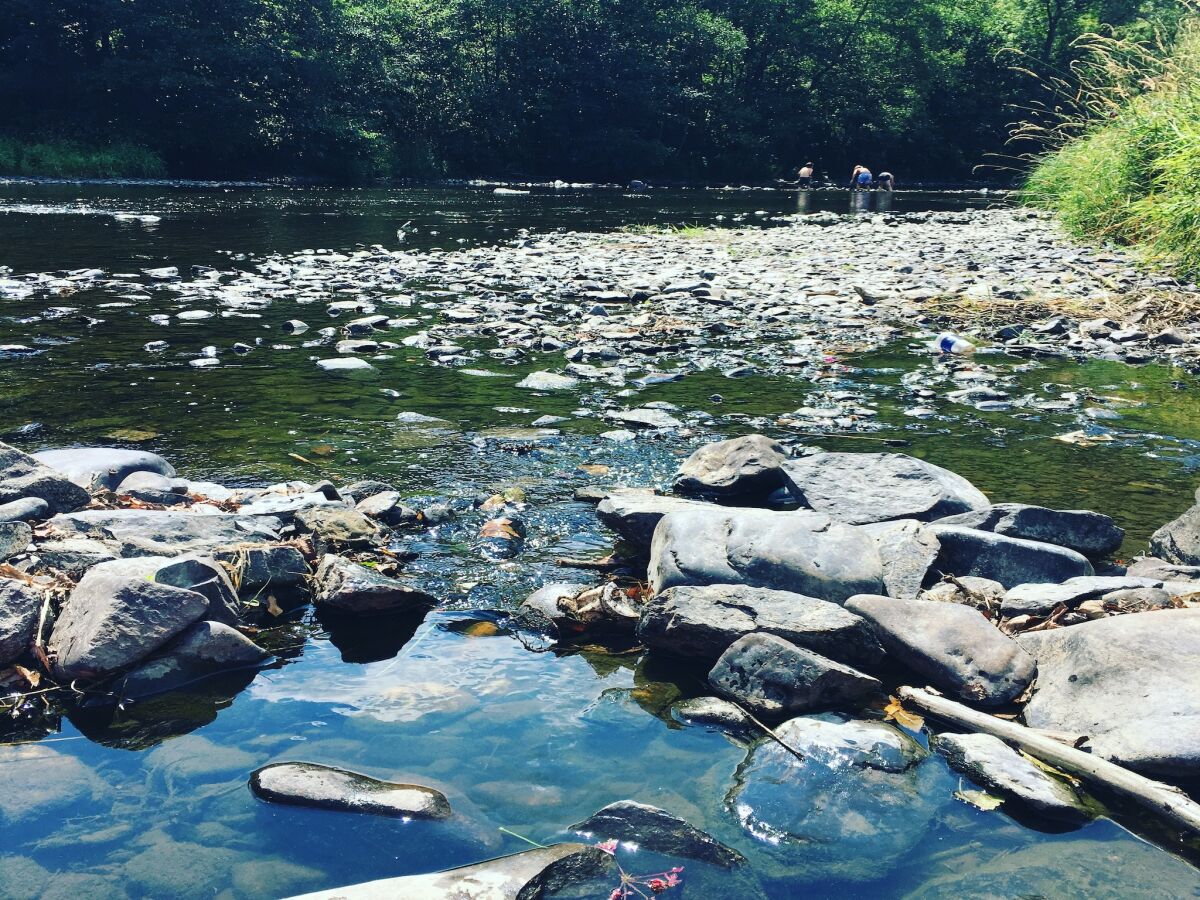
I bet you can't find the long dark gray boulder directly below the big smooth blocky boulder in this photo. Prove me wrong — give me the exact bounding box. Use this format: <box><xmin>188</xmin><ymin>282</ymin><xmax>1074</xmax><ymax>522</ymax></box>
<box><xmin>637</xmin><ymin>584</ymin><xmax>883</xmax><ymax>668</ymax></box>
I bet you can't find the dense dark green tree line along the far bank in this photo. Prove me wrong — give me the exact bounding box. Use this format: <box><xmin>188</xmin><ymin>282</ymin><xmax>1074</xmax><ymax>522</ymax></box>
<box><xmin>0</xmin><ymin>0</ymin><xmax>1171</xmax><ymax>180</ymax></box>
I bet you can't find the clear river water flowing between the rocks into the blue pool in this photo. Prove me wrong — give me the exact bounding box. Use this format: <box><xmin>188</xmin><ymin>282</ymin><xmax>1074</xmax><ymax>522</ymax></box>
<box><xmin>0</xmin><ymin>185</ymin><xmax>1200</xmax><ymax>898</ymax></box>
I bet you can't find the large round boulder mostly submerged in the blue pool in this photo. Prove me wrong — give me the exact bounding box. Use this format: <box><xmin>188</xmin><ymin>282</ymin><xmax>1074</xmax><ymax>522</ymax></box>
<box><xmin>725</xmin><ymin>715</ymin><xmax>940</xmax><ymax>882</ymax></box>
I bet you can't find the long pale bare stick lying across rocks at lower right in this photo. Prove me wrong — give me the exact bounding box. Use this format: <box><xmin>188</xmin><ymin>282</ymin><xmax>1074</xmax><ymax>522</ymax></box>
<box><xmin>896</xmin><ymin>688</ymin><xmax>1200</xmax><ymax>836</ymax></box>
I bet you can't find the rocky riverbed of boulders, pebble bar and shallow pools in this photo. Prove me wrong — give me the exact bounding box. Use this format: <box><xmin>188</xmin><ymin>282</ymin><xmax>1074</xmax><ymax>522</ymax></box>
<box><xmin>0</xmin><ymin>194</ymin><xmax>1200</xmax><ymax>898</ymax></box>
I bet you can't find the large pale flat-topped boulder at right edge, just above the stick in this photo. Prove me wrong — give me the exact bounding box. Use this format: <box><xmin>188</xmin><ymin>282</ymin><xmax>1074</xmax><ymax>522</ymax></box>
<box><xmin>1016</xmin><ymin>610</ymin><xmax>1200</xmax><ymax>778</ymax></box>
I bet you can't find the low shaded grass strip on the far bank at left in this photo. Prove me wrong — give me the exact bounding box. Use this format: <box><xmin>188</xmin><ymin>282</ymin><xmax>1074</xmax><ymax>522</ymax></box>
<box><xmin>0</xmin><ymin>137</ymin><xmax>167</xmax><ymax>178</ymax></box>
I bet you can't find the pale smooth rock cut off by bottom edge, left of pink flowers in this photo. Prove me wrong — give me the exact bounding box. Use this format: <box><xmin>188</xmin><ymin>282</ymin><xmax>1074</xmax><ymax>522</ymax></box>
<box><xmin>280</xmin><ymin>844</ymin><xmax>612</xmax><ymax>900</ymax></box>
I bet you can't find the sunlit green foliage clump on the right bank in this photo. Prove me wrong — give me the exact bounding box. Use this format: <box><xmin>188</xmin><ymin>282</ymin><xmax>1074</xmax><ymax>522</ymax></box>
<box><xmin>1025</xmin><ymin>20</ymin><xmax>1200</xmax><ymax>277</ymax></box>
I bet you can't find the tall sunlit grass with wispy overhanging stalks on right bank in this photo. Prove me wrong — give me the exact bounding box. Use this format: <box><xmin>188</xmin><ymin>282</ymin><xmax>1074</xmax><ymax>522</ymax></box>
<box><xmin>1015</xmin><ymin>16</ymin><xmax>1200</xmax><ymax>277</ymax></box>
